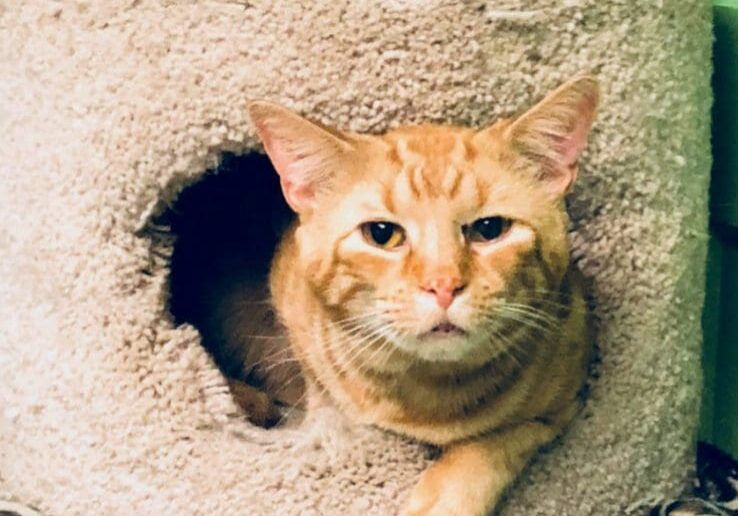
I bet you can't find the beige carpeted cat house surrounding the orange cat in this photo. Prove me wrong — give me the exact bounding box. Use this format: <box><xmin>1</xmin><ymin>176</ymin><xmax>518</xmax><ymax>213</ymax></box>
<box><xmin>0</xmin><ymin>0</ymin><xmax>711</xmax><ymax>516</ymax></box>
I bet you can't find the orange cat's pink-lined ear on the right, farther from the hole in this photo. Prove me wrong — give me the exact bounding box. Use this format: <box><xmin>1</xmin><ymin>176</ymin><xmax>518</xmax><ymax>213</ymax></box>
<box><xmin>504</xmin><ymin>75</ymin><xmax>599</xmax><ymax>196</ymax></box>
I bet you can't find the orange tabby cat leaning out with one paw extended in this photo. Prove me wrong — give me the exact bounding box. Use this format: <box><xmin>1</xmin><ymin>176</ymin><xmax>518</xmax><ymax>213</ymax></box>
<box><xmin>249</xmin><ymin>76</ymin><xmax>598</xmax><ymax>515</ymax></box>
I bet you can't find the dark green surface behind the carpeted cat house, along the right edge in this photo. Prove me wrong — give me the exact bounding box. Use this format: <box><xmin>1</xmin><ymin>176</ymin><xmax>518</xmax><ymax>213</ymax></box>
<box><xmin>701</xmin><ymin>0</ymin><xmax>738</xmax><ymax>457</ymax></box>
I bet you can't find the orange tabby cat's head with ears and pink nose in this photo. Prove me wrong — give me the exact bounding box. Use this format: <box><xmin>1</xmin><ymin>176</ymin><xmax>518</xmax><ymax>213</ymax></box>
<box><xmin>249</xmin><ymin>76</ymin><xmax>598</xmax><ymax>361</ymax></box>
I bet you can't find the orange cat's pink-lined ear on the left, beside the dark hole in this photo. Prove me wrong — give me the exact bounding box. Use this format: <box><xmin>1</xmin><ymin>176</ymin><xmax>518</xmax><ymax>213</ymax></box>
<box><xmin>248</xmin><ymin>101</ymin><xmax>352</xmax><ymax>213</ymax></box>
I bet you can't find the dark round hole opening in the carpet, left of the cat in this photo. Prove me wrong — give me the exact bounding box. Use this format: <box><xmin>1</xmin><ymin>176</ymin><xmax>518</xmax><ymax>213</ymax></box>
<box><xmin>154</xmin><ymin>153</ymin><xmax>304</xmax><ymax>427</ymax></box>
